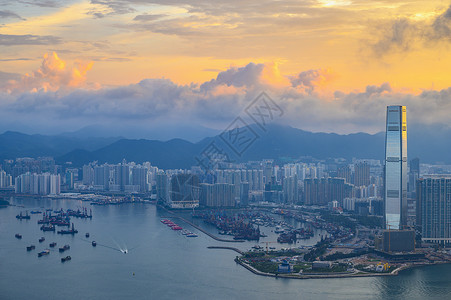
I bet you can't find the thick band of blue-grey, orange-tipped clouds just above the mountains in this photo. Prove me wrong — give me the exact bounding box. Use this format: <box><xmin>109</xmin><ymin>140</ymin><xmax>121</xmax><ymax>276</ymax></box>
<box><xmin>0</xmin><ymin>53</ymin><xmax>451</xmax><ymax>133</ymax></box>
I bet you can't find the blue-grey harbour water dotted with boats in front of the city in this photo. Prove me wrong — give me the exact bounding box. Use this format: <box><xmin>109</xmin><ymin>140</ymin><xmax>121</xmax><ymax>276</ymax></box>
<box><xmin>0</xmin><ymin>199</ymin><xmax>451</xmax><ymax>300</ymax></box>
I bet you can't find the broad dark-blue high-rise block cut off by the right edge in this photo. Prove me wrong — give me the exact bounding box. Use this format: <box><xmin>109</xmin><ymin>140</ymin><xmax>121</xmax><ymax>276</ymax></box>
<box><xmin>416</xmin><ymin>175</ymin><xmax>451</xmax><ymax>244</ymax></box>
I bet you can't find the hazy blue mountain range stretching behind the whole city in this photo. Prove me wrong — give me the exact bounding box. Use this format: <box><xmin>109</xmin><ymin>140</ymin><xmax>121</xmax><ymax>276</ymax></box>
<box><xmin>0</xmin><ymin>124</ymin><xmax>451</xmax><ymax>169</ymax></box>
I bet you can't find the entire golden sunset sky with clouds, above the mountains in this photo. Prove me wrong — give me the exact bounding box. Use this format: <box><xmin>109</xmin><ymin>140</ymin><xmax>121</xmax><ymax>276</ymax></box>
<box><xmin>0</xmin><ymin>0</ymin><xmax>451</xmax><ymax>134</ymax></box>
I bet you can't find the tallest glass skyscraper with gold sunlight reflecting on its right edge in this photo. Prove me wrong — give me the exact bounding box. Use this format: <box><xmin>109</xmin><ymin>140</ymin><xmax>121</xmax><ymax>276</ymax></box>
<box><xmin>384</xmin><ymin>105</ymin><xmax>407</xmax><ymax>229</ymax></box>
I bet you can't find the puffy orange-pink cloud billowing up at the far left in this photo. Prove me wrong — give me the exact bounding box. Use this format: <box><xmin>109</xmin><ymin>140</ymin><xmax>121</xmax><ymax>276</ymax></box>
<box><xmin>8</xmin><ymin>52</ymin><xmax>93</xmax><ymax>92</ymax></box>
